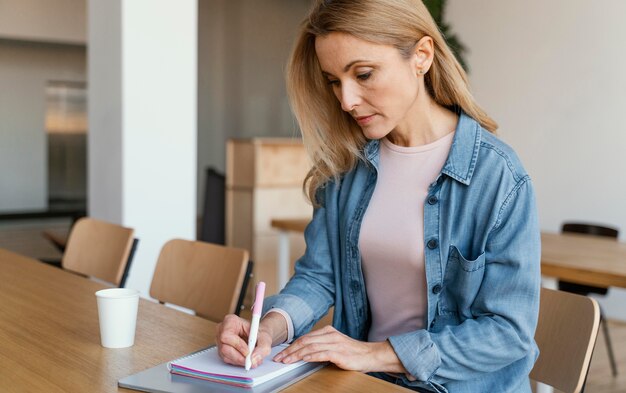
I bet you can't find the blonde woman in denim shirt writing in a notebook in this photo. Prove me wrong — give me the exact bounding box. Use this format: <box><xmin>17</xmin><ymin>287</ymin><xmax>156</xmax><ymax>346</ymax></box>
<box><xmin>217</xmin><ymin>0</ymin><xmax>540</xmax><ymax>393</ymax></box>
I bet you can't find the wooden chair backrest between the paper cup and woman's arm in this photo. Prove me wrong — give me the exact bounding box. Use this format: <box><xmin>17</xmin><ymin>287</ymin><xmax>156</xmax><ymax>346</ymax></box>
<box><xmin>150</xmin><ymin>239</ymin><xmax>248</xmax><ymax>322</ymax></box>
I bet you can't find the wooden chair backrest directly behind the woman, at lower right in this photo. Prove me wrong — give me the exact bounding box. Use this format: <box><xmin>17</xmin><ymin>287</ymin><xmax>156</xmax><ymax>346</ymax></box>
<box><xmin>530</xmin><ymin>288</ymin><xmax>600</xmax><ymax>393</ymax></box>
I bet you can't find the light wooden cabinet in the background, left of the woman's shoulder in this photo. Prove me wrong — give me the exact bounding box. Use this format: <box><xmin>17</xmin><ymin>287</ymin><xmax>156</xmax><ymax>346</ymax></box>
<box><xmin>226</xmin><ymin>138</ymin><xmax>313</xmax><ymax>300</ymax></box>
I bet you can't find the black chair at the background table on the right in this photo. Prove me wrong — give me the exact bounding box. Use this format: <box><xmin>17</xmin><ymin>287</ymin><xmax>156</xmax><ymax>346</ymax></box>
<box><xmin>558</xmin><ymin>222</ymin><xmax>619</xmax><ymax>377</ymax></box>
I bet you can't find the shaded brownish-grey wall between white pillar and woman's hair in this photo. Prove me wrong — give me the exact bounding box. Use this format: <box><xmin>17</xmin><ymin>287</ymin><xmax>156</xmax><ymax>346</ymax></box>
<box><xmin>198</xmin><ymin>0</ymin><xmax>310</xmax><ymax>208</ymax></box>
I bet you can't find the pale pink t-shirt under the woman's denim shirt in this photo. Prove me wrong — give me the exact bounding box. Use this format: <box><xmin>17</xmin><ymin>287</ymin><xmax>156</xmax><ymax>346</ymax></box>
<box><xmin>359</xmin><ymin>132</ymin><xmax>454</xmax><ymax>342</ymax></box>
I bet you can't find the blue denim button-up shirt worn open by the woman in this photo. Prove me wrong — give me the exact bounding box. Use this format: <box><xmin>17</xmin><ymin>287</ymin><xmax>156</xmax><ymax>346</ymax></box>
<box><xmin>265</xmin><ymin>113</ymin><xmax>541</xmax><ymax>393</ymax></box>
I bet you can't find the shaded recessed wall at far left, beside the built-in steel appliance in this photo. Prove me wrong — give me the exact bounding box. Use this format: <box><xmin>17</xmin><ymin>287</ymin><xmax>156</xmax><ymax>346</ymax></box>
<box><xmin>0</xmin><ymin>40</ymin><xmax>86</xmax><ymax>213</ymax></box>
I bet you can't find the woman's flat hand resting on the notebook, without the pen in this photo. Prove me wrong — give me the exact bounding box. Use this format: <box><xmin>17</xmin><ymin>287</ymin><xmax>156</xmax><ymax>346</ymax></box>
<box><xmin>274</xmin><ymin>326</ymin><xmax>406</xmax><ymax>373</ymax></box>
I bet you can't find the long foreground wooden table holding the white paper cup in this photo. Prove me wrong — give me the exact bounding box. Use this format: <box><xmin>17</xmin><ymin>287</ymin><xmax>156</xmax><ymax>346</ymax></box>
<box><xmin>0</xmin><ymin>249</ymin><xmax>406</xmax><ymax>393</ymax></box>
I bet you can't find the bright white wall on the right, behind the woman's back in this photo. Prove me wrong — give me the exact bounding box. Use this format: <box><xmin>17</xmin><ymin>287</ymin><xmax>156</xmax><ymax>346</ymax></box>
<box><xmin>447</xmin><ymin>0</ymin><xmax>626</xmax><ymax>319</ymax></box>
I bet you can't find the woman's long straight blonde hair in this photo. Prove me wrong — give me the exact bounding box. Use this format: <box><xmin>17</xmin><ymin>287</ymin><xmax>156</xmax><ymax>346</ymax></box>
<box><xmin>287</xmin><ymin>0</ymin><xmax>497</xmax><ymax>202</ymax></box>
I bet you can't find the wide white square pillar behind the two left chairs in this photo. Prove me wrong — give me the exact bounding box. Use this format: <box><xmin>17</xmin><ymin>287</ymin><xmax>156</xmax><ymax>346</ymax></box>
<box><xmin>89</xmin><ymin>0</ymin><xmax>197</xmax><ymax>296</ymax></box>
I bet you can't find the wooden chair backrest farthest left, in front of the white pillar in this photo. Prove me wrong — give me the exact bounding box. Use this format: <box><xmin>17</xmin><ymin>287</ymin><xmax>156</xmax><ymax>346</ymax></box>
<box><xmin>61</xmin><ymin>217</ymin><xmax>134</xmax><ymax>286</ymax></box>
